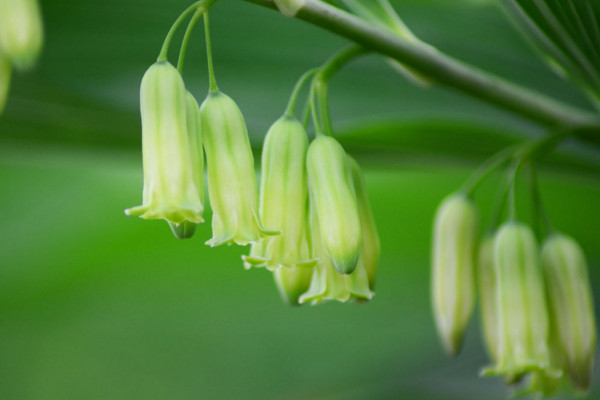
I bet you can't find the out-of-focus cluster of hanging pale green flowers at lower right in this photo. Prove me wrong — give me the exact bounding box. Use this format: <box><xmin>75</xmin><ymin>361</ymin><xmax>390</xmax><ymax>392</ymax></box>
<box><xmin>432</xmin><ymin>193</ymin><xmax>596</xmax><ymax>395</ymax></box>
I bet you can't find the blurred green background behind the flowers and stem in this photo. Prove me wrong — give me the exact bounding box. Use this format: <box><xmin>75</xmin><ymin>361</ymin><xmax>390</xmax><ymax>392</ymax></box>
<box><xmin>0</xmin><ymin>0</ymin><xmax>600</xmax><ymax>400</ymax></box>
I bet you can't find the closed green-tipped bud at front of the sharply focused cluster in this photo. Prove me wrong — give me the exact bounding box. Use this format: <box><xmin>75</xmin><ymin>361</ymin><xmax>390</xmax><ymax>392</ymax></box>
<box><xmin>307</xmin><ymin>136</ymin><xmax>362</xmax><ymax>274</ymax></box>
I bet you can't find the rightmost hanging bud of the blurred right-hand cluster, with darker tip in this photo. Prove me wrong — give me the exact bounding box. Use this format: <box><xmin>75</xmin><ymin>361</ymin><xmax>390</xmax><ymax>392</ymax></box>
<box><xmin>542</xmin><ymin>234</ymin><xmax>596</xmax><ymax>390</ymax></box>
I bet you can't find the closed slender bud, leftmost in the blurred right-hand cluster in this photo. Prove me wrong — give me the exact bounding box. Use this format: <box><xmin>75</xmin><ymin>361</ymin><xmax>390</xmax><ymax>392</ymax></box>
<box><xmin>431</xmin><ymin>193</ymin><xmax>479</xmax><ymax>355</ymax></box>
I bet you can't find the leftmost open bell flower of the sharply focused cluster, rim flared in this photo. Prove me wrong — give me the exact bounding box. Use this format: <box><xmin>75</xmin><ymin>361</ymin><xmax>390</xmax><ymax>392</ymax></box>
<box><xmin>125</xmin><ymin>62</ymin><xmax>203</xmax><ymax>225</ymax></box>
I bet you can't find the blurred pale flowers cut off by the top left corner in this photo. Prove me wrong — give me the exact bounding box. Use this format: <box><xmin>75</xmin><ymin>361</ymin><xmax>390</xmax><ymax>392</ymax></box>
<box><xmin>0</xmin><ymin>0</ymin><xmax>44</xmax><ymax>113</ymax></box>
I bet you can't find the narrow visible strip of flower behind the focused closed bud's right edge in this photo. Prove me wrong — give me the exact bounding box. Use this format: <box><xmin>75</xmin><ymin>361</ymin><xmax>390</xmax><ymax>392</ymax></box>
<box><xmin>348</xmin><ymin>157</ymin><xmax>381</xmax><ymax>290</ymax></box>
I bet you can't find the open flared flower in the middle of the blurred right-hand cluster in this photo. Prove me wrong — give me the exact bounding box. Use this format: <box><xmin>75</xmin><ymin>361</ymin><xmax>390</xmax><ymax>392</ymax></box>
<box><xmin>491</xmin><ymin>222</ymin><xmax>554</xmax><ymax>381</ymax></box>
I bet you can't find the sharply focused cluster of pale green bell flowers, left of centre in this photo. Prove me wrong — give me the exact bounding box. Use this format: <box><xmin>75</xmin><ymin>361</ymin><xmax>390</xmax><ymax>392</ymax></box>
<box><xmin>126</xmin><ymin>12</ymin><xmax>379</xmax><ymax>305</ymax></box>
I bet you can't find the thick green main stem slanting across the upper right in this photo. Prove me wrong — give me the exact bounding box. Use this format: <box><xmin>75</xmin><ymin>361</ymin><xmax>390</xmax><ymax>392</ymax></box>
<box><xmin>246</xmin><ymin>0</ymin><xmax>600</xmax><ymax>130</ymax></box>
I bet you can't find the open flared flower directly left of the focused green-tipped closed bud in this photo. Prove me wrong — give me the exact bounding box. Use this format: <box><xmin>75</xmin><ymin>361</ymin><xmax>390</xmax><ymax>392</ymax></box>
<box><xmin>244</xmin><ymin>116</ymin><xmax>316</xmax><ymax>270</ymax></box>
